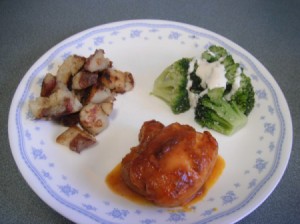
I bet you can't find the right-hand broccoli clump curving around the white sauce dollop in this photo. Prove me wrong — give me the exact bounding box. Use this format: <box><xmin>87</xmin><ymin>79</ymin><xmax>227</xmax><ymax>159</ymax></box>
<box><xmin>195</xmin><ymin>46</ymin><xmax>255</xmax><ymax>135</ymax></box>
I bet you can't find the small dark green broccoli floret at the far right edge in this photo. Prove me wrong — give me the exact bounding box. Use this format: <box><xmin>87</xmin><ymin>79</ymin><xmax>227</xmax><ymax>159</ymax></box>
<box><xmin>230</xmin><ymin>73</ymin><xmax>255</xmax><ymax>116</ymax></box>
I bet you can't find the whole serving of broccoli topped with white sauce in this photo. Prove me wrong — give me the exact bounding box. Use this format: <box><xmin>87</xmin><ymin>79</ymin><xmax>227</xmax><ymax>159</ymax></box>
<box><xmin>152</xmin><ymin>45</ymin><xmax>255</xmax><ymax>135</ymax></box>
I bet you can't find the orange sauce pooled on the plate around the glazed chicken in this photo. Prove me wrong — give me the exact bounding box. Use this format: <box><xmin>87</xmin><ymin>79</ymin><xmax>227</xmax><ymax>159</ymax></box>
<box><xmin>106</xmin><ymin>155</ymin><xmax>225</xmax><ymax>211</ymax></box>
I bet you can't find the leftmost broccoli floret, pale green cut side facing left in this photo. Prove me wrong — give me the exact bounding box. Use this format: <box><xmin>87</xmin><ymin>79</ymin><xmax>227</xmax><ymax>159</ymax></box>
<box><xmin>152</xmin><ymin>58</ymin><xmax>191</xmax><ymax>114</ymax></box>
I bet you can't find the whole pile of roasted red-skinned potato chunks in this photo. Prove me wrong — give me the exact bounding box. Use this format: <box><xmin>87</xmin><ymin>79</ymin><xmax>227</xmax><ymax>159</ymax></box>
<box><xmin>29</xmin><ymin>49</ymin><xmax>134</xmax><ymax>153</ymax></box>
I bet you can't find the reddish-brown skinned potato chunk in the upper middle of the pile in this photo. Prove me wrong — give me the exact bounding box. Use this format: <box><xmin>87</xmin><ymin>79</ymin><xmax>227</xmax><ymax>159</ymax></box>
<box><xmin>72</xmin><ymin>70</ymin><xmax>98</xmax><ymax>90</ymax></box>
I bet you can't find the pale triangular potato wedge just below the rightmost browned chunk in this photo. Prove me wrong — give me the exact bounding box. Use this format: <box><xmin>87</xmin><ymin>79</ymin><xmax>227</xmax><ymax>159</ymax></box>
<box><xmin>85</xmin><ymin>83</ymin><xmax>115</xmax><ymax>104</ymax></box>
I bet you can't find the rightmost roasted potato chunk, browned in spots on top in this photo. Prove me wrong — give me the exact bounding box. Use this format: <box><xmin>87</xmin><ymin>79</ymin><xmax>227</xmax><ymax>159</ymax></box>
<box><xmin>100</xmin><ymin>68</ymin><xmax>134</xmax><ymax>93</ymax></box>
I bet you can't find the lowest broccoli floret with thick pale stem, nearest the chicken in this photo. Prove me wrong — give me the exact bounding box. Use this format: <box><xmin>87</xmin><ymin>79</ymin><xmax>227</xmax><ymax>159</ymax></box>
<box><xmin>195</xmin><ymin>89</ymin><xmax>247</xmax><ymax>135</ymax></box>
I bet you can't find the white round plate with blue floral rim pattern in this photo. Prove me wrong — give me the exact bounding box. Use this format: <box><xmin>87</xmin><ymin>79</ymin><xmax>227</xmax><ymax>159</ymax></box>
<box><xmin>8</xmin><ymin>20</ymin><xmax>292</xmax><ymax>224</ymax></box>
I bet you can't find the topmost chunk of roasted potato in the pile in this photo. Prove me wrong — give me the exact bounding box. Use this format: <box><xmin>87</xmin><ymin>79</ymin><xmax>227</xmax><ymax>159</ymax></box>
<box><xmin>84</xmin><ymin>49</ymin><xmax>112</xmax><ymax>72</ymax></box>
